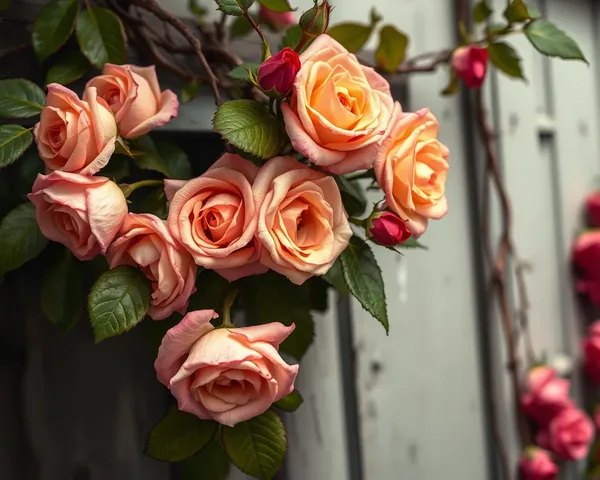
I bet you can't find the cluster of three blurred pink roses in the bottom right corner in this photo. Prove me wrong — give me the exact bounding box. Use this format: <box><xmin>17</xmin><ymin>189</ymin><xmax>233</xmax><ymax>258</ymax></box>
<box><xmin>521</xmin><ymin>366</ymin><xmax>594</xmax><ymax>480</ymax></box>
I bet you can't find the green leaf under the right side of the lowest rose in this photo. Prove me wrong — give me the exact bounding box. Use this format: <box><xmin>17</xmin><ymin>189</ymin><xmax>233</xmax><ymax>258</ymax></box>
<box><xmin>223</xmin><ymin>410</ymin><xmax>287</xmax><ymax>480</ymax></box>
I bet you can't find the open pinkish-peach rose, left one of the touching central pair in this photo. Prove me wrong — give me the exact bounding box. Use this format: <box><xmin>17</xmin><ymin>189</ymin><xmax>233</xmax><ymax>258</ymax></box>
<box><xmin>165</xmin><ymin>153</ymin><xmax>267</xmax><ymax>281</ymax></box>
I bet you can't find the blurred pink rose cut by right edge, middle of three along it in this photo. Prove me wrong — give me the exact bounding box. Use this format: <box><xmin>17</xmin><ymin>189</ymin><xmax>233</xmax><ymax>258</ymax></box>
<box><xmin>573</xmin><ymin>230</ymin><xmax>600</xmax><ymax>306</ymax></box>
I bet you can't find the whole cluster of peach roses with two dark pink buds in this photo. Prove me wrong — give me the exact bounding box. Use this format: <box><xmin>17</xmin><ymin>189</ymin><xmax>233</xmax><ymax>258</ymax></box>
<box><xmin>29</xmin><ymin>35</ymin><xmax>448</xmax><ymax>425</ymax></box>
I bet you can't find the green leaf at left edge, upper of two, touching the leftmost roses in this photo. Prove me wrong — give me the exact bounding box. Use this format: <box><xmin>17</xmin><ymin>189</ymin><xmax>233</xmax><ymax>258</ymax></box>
<box><xmin>0</xmin><ymin>78</ymin><xmax>46</xmax><ymax>118</ymax></box>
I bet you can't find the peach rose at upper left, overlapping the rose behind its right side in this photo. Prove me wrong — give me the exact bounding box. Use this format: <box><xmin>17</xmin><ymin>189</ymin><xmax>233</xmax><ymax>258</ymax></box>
<box><xmin>33</xmin><ymin>83</ymin><xmax>117</xmax><ymax>175</ymax></box>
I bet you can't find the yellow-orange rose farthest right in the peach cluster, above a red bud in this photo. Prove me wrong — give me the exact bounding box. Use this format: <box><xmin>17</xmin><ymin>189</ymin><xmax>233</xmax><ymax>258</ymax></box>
<box><xmin>374</xmin><ymin>103</ymin><xmax>449</xmax><ymax>237</ymax></box>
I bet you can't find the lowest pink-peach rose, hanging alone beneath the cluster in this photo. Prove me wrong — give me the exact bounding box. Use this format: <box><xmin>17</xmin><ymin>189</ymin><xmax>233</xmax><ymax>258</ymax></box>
<box><xmin>154</xmin><ymin>310</ymin><xmax>298</xmax><ymax>427</ymax></box>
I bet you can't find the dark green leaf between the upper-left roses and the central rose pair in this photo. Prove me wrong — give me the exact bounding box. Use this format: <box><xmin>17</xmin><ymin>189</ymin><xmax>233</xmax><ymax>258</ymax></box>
<box><xmin>133</xmin><ymin>135</ymin><xmax>192</xmax><ymax>180</ymax></box>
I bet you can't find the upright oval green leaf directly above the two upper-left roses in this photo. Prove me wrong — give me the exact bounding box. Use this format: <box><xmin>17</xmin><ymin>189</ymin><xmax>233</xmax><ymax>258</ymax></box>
<box><xmin>75</xmin><ymin>7</ymin><xmax>127</xmax><ymax>70</ymax></box>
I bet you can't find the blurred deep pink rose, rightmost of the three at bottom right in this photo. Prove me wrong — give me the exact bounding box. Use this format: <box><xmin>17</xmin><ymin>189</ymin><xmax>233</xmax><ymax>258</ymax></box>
<box><xmin>537</xmin><ymin>408</ymin><xmax>594</xmax><ymax>460</ymax></box>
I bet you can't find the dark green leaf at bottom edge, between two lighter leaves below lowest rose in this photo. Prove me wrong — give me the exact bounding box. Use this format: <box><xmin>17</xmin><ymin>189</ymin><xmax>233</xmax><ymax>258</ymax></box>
<box><xmin>180</xmin><ymin>435</ymin><xmax>231</xmax><ymax>480</ymax></box>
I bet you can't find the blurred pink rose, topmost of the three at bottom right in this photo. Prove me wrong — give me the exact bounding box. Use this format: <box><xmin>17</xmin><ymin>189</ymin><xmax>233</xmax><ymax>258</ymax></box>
<box><xmin>522</xmin><ymin>367</ymin><xmax>573</xmax><ymax>425</ymax></box>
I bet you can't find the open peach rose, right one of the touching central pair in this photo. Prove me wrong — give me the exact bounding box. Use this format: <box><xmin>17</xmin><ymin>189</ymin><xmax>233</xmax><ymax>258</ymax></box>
<box><xmin>253</xmin><ymin>157</ymin><xmax>352</xmax><ymax>285</ymax></box>
